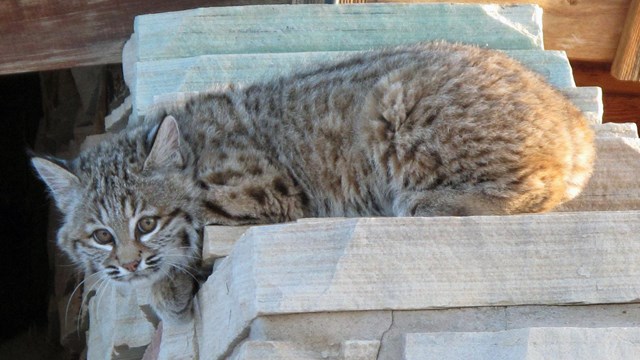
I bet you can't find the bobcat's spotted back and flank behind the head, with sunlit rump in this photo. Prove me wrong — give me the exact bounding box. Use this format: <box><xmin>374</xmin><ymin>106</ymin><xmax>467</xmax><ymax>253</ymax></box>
<box><xmin>161</xmin><ymin>43</ymin><xmax>594</xmax><ymax>217</ymax></box>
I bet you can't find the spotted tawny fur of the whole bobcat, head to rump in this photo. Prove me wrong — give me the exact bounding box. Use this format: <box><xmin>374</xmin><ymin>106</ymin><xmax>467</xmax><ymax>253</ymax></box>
<box><xmin>36</xmin><ymin>42</ymin><xmax>594</xmax><ymax>317</ymax></box>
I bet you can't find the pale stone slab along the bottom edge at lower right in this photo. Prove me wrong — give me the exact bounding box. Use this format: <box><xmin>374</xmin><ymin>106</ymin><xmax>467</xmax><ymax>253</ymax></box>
<box><xmin>403</xmin><ymin>328</ymin><xmax>640</xmax><ymax>360</ymax></box>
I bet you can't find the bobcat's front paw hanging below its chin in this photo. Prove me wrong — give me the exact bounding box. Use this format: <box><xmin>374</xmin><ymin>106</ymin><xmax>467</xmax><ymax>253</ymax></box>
<box><xmin>151</xmin><ymin>271</ymin><xmax>195</xmax><ymax>323</ymax></box>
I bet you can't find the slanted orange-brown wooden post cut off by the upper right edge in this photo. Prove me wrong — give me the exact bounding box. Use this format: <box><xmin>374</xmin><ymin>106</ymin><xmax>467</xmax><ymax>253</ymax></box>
<box><xmin>611</xmin><ymin>0</ymin><xmax>640</xmax><ymax>81</ymax></box>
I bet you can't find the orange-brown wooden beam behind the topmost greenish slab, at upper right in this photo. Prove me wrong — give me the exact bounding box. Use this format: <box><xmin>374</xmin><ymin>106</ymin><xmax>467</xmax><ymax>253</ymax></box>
<box><xmin>339</xmin><ymin>0</ymin><xmax>631</xmax><ymax>62</ymax></box>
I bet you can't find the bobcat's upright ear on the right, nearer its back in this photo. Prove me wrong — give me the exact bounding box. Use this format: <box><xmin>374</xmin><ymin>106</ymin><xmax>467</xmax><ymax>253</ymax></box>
<box><xmin>144</xmin><ymin>116</ymin><xmax>184</xmax><ymax>170</ymax></box>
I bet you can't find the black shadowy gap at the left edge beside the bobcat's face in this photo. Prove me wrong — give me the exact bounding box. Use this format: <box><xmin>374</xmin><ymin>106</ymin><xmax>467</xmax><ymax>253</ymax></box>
<box><xmin>0</xmin><ymin>73</ymin><xmax>51</xmax><ymax>340</ymax></box>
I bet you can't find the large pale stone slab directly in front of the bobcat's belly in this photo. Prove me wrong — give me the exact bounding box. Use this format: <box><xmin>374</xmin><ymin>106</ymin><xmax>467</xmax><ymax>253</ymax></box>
<box><xmin>198</xmin><ymin>211</ymin><xmax>640</xmax><ymax>357</ymax></box>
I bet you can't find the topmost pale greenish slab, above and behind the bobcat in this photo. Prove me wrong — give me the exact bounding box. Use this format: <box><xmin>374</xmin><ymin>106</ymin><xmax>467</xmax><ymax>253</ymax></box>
<box><xmin>134</xmin><ymin>4</ymin><xmax>542</xmax><ymax>61</ymax></box>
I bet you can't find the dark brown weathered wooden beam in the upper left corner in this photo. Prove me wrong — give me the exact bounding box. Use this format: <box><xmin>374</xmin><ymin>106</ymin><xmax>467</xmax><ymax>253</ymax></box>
<box><xmin>0</xmin><ymin>0</ymin><xmax>291</xmax><ymax>75</ymax></box>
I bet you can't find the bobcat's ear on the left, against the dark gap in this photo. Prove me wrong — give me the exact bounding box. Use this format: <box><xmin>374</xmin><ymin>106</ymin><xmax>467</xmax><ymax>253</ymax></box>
<box><xmin>31</xmin><ymin>157</ymin><xmax>80</xmax><ymax>213</ymax></box>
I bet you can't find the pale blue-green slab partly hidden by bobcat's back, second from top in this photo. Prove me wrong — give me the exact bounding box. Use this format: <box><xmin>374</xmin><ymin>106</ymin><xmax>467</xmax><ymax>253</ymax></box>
<box><xmin>125</xmin><ymin>50</ymin><xmax>575</xmax><ymax>119</ymax></box>
